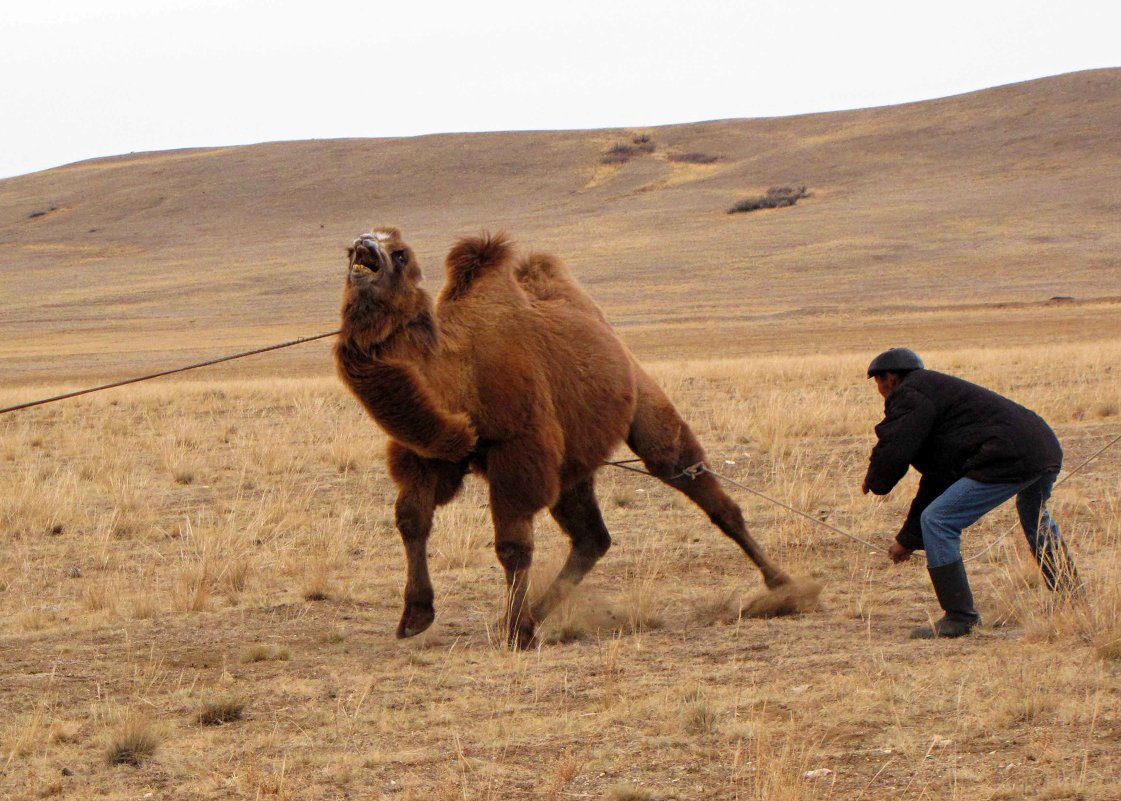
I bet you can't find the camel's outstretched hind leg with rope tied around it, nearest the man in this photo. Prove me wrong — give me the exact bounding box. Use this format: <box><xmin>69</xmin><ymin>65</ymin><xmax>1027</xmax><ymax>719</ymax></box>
<box><xmin>627</xmin><ymin>370</ymin><xmax>790</xmax><ymax>588</ymax></box>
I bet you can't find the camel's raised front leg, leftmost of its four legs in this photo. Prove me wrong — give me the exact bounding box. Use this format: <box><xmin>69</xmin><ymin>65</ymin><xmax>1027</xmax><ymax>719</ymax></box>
<box><xmin>389</xmin><ymin>443</ymin><xmax>466</xmax><ymax>639</ymax></box>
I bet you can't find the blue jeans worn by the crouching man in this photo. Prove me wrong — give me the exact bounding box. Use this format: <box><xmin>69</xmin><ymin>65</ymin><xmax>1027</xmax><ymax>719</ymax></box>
<box><xmin>919</xmin><ymin>473</ymin><xmax>1063</xmax><ymax>567</ymax></box>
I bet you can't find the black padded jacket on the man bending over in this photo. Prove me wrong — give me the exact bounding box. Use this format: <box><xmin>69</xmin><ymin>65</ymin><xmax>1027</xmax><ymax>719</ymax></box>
<box><xmin>864</xmin><ymin>370</ymin><xmax>1063</xmax><ymax>550</ymax></box>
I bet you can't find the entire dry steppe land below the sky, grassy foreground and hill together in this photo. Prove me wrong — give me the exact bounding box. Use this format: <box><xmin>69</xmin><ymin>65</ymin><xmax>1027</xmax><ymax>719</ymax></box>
<box><xmin>0</xmin><ymin>69</ymin><xmax>1121</xmax><ymax>801</ymax></box>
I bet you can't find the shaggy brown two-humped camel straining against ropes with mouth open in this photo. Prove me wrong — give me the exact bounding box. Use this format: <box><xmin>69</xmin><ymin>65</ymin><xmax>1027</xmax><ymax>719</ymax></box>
<box><xmin>335</xmin><ymin>227</ymin><xmax>816</xmax><ymax>649</ymax></box>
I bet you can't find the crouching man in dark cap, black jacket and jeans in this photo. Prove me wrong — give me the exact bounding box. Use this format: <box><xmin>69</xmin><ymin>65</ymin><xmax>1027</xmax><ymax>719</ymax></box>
<box><xmin>862</xmin><ymin>347</ymin><xmax>1077</xmax><ymax>639</ymax></box>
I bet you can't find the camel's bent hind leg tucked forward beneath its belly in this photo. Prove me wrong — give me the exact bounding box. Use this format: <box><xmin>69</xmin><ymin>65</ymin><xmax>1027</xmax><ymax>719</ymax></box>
<box><xmin>531</xmin><ymin>476</ymin><xmax>611</xmax><ymax>621</ymax></box>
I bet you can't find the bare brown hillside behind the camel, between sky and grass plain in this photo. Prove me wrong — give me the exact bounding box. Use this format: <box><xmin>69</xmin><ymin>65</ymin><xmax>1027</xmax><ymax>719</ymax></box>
<box><xmin>0</xmin><ymin>69</ymin><xmax>1121</xmax><ymax>382</ymax></box>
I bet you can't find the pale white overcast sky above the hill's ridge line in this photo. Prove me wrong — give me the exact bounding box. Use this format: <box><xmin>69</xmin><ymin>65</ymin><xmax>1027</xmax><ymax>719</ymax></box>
<box><xmin>0</xmin><ymin>0</ymin><xmax>1121</xmax><ymax>178</ymax></box>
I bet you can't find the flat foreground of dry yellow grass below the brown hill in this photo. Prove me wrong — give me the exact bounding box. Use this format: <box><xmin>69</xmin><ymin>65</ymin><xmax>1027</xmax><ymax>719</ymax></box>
<box><xmin>0</xmin><ymin>344</ymin><xmax>1121</xmax><ymax>801</ymax></box>
